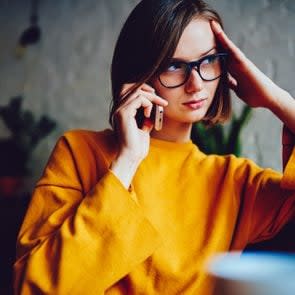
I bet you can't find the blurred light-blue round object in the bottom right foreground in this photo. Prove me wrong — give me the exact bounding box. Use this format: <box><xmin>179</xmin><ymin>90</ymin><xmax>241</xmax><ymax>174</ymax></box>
<box><xmin>207</xmin><ymin>252</ymin><xmax>295</xmax><ymax>295</ymax></box>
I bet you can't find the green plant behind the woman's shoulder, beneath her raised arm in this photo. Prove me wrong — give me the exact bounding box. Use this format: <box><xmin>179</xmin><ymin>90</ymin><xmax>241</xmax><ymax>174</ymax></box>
<box><xmin>191</xmin><ymin>105</ymin><xmax>252</xmax><ymax>156</ymax></box>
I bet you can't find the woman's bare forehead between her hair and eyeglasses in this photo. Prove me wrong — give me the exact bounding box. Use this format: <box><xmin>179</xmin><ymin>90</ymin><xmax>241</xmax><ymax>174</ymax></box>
<box><xmin>173</xmin><ymin>19</ymin><xmax>216</xmax><ymax>61</ymax></box>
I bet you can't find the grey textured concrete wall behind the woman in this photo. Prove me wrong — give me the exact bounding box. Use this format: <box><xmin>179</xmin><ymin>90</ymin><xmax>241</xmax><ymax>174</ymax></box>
<box><xmin>0</xmin><ymin>0</ymin><xmax>295</xmax><ymax>190</ymax></box>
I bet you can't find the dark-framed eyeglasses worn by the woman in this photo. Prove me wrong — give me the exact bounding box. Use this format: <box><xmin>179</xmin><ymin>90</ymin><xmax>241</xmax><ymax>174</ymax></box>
<box><xmin>159</xmin><ymin>53</ymin><xmax>227</xmax><ymax>88</ymax></box>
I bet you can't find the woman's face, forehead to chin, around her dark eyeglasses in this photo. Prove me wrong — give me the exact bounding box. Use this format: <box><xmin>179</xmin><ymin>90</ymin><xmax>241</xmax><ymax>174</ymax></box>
<box><xmin>153</xmin><ymin>19</ymin><xmax>219</xmax><ymax>123</ymax></box>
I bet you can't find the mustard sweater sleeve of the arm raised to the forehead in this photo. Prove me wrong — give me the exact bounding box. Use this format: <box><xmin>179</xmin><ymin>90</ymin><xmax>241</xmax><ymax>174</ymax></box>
<box><xmin>234</xmin><ymin>127</ymin><xmax>295</xmax><ymax>248</ymax></box>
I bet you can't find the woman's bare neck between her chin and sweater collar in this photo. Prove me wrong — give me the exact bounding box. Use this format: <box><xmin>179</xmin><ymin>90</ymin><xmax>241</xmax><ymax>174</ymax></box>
<box><xmin>151</xmin><ymin>121</ymin><xmax>192</xmax><ymax>142</ymax></box>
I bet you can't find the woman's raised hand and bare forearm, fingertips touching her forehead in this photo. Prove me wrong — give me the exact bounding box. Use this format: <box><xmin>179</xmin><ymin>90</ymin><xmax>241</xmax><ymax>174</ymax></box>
<box><xmin>211</xmin><ymin>21</ymin><xmax>295</xmax><ymax>134</ymax></box>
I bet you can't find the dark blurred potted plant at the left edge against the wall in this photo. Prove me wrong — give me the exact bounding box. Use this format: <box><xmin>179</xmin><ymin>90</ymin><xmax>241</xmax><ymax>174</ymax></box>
<box><xmin>0</xmin><ymin>96</ymin><xmax>56</xmax><ymax>176</ymax></box>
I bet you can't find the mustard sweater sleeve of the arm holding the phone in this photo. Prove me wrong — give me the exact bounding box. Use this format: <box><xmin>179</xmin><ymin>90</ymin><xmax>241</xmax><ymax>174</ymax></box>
<box><xmin>14</xmin><ymin>137</ymin><xmax>159</xmax><ymax>294</ymax></box>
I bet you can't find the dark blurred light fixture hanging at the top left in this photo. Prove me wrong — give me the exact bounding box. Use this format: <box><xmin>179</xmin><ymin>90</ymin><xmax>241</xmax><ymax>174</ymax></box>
<box><xmin>16</xmin><ymin>0</ymin><xmax>41</xmax><ymax>57</ymax></box>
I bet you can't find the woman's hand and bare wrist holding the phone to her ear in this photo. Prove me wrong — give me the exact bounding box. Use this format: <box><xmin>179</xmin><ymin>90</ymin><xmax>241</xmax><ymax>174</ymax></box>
<box><xmin>110</xmin><ymin>84</ymin><xmax>168</xmax><ymax>188</ymax></box>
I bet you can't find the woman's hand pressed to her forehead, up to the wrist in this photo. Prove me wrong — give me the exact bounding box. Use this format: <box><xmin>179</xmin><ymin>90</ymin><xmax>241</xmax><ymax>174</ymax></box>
<box><xmin>211</xmin><ymin>21</ymin><xmax>285</xmax><ymax>109</ymax></box>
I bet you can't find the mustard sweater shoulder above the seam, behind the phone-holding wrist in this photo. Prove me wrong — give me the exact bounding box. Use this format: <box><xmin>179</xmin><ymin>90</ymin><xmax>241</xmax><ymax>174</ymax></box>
<box><xmin>39</xmin><ymin>129</ymin><xmax>117</xmax><ymax>191</ymax></box>
